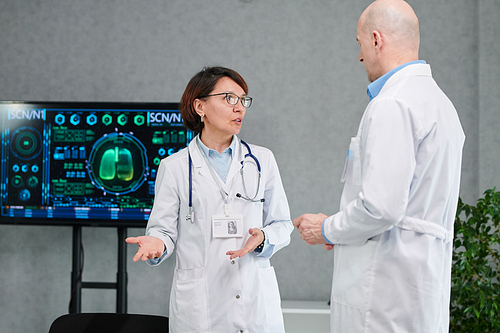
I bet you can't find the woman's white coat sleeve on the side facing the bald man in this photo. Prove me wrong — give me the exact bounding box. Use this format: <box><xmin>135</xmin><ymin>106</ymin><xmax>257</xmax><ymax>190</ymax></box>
<box><xmin>258</xmin><ymin>151</ymin><xmax>293</xmax><ymax>259</ymax></box>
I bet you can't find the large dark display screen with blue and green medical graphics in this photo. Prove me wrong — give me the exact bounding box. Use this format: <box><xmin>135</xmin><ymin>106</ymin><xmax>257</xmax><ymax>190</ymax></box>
<box><xmin>0</xmin><ymin>102</ymin><xmax>194</xmax><ymax>226</ymax></box>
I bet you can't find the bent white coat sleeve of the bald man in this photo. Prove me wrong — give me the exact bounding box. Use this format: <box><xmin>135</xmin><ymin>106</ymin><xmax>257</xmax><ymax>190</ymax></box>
<box><xmin>323</xmin><ymin>98</ymin><xmax>423</xmax><ymax>245</ymax></box>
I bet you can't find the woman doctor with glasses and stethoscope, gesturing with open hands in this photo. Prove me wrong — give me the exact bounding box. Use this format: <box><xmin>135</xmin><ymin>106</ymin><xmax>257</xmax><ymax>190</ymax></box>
<box><xmin>127</xmin><ymin>67</ymin><xmax>293</xmax><ymax>333</ymax></box>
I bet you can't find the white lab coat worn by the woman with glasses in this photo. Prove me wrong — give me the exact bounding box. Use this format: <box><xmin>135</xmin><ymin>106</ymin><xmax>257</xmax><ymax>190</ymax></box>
<box><xmin>147</xmin><ymin>138</ymin><xmax>293</xmax><ymax>333</ymax></box>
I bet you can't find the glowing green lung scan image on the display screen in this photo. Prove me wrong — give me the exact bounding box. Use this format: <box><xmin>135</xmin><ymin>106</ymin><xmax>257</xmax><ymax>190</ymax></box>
<box><xmin>99</xmin><ymin>147</ymin><xmax>134</xmax><ymax>181</ymax></box>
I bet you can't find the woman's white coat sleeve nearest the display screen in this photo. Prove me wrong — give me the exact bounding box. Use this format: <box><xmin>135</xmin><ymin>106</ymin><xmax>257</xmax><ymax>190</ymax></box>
<box><xmin>146</xmin><ymin>160</ymin><xmax>180</xmax><ymax>265</ymax></box>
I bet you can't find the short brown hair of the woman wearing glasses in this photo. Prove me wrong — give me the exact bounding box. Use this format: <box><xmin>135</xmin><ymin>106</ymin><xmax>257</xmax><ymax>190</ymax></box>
<box><xmin>179</xmin><ymin>66</ymin><xmax>248</xmax><ymax>133</ymax></box>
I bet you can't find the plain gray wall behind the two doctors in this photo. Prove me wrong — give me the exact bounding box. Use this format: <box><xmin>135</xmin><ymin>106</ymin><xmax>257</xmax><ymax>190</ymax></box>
<box><xmin>0</xmin><ymin>0</ymin><xmax>500</xmax><ymax>332</ymax></box>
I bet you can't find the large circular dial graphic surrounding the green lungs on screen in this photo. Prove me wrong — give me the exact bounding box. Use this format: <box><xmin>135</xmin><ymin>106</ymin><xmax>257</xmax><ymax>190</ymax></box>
<box><xmin>87</xmin><ymin>133</ymin><xmax>148</xmax><ymax>195</ymax></box>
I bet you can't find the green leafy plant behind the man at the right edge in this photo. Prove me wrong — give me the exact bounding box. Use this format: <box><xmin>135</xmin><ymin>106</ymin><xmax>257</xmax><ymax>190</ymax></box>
<box><xmin>450</xmin><ymin>188</ymin><xmax>500</xmax><ymax>333</ymax></box>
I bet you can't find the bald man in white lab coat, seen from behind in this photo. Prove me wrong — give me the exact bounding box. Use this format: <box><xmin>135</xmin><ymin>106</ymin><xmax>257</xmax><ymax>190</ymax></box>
<box><xmin>294</xmin><ymin>0</ymin><xmax>465</xmax><ymax>333</ymax></box>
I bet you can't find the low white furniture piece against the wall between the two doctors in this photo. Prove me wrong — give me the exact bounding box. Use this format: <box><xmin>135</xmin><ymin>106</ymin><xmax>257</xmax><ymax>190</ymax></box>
<box><xmin>281</xmin><ymin>301</ymin><xmax>330</xmax><ymax>333</ymax></box>
